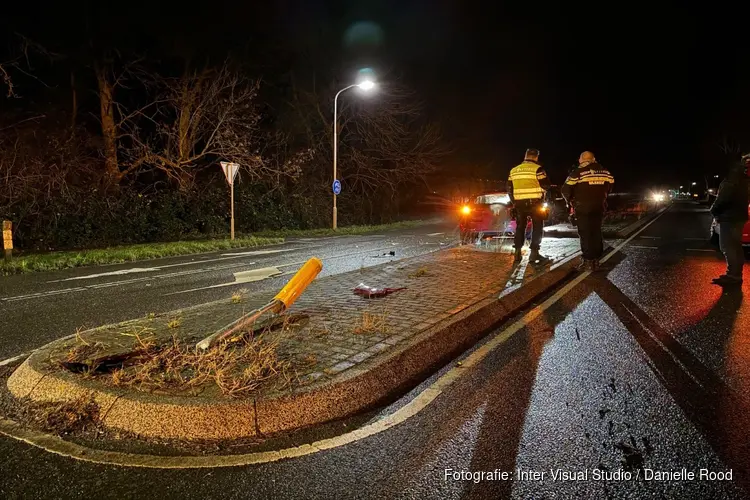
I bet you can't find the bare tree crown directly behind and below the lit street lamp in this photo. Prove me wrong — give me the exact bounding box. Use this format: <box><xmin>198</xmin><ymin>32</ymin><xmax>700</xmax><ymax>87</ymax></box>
<box><xmin>290</xmin><ymin>77</ymin><xmax>449</xmax><ymax>198</ymax></box>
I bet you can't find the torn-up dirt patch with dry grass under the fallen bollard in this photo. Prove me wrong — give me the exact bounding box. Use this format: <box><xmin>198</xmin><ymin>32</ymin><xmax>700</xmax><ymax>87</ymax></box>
<box><xmin>50</xmin><ymin>314</ymin><xmax>310</xmax><ymax>397</ymax></box>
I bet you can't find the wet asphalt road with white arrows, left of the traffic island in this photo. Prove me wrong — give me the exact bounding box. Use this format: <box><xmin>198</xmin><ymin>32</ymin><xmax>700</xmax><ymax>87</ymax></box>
<box><xmin>0</xmin><ymin>222</ymin><xmax>457</xmax><ymax>359</ymax></box>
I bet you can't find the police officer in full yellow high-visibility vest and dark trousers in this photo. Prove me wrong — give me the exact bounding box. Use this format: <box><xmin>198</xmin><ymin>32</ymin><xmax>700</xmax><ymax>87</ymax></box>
<box><xmin>508</xmin><ymin>149</ymin><xmax>550</xmax><ymax>263</ymax></box>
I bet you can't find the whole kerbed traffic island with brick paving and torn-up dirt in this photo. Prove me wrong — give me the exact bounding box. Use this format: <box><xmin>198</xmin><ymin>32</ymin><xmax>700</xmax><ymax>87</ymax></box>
<box><xmin>4</xmin><ymin>240</ymin><xmax>578</xmax><ymax>450</ymax></box>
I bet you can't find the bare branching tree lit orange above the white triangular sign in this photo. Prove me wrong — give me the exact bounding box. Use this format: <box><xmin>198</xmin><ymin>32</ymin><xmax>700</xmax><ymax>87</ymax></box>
<box><xmin>117</xmin><ymin>64</ymin><xmax>299</xmax><ymax>189</ymax></box>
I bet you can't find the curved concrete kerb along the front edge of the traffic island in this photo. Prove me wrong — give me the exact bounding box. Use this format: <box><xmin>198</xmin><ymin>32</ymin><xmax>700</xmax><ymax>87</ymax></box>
<box><xmin>8</xmin><ymin>254</ymin><xmax>576</xmax><ymax>439</ymax></box>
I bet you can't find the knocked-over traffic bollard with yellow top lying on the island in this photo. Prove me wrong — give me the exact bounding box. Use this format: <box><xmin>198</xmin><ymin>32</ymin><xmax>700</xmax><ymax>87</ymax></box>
<box><xmin>196</xmin><ymin>257</ymin><xmax>323</xmax><ymax>350</ymax></box>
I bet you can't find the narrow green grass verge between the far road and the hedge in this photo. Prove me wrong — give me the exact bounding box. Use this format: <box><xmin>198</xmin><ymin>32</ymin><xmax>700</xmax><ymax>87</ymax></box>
<box><xmin>0</xmin><ymin>221</ymin><xmax>432</xmax><ymax>275</ymax></box>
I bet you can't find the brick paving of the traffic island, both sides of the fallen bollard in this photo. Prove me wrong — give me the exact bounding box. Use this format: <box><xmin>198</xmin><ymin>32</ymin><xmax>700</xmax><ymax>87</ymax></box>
<box><xmin>64</xmin><ymin>238</ymin><xmax>579</xmax><ymax>391</ymax></box>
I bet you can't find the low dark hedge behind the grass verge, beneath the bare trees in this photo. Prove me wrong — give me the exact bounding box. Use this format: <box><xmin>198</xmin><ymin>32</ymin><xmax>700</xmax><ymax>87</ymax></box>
<box><xmin>0</xmin><ymin>179</ymin><xmax>418</xmax><ymax>251</ymax></box>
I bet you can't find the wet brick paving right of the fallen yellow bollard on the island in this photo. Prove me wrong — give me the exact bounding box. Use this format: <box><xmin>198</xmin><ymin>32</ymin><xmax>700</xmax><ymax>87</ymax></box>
<box><xmin>281</xmin><ymin>238</ymin><xmax>579</xmax><ymax>383</ymax></box>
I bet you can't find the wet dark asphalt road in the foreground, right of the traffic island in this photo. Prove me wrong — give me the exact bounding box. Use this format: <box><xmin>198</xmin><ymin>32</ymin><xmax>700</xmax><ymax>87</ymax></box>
<box><xmin>0</xmin><ymin>204</ymin><xmax>750</xmax><ymax>499</ymax></box>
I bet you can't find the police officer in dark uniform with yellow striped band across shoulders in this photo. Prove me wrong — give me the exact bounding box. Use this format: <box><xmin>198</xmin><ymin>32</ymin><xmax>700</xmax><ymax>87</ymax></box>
<box><xmin>560</xmin><ymin>151</ymin><xmax>615</xmax><ymax>271</ymax></box>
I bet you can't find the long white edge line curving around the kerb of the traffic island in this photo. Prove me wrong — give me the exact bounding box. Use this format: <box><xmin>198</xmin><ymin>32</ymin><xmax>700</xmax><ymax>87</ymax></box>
<box><xmin>0</xmin><ymin>212</ymin><xmax>664</xmax><ymax>469</ymax></box>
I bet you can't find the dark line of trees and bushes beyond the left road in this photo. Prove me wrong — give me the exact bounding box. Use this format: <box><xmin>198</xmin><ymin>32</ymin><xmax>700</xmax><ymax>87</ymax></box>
<box><xmin>0</xmin><ymin>23</ymin><xmax>447</xmax><ymax>250</ymax></box>
